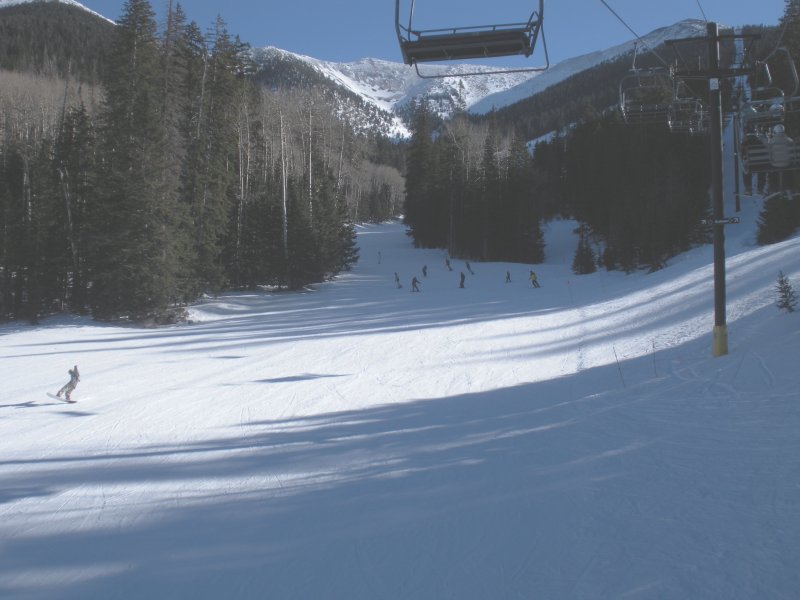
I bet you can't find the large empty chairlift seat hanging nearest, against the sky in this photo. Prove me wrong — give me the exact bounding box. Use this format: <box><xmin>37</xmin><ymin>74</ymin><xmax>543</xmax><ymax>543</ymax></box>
<box><xmin>395</xmin><ymin>0</ymin><xmax>550</xmax><ymax>79</ymax></box>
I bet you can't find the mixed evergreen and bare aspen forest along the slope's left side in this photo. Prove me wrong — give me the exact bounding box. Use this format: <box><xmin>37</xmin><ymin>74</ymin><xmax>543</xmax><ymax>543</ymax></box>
<box><xmin>0</xmin><ymin>0</ymin><xmax>403</xmax><ymax>319</ymax></box>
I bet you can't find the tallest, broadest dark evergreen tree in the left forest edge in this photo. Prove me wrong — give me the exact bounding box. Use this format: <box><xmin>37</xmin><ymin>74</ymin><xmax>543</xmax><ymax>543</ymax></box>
<box><xmin>92</xmin><ymin>0</ymin><xmax>185</xmax><ymax>318</ymax></box>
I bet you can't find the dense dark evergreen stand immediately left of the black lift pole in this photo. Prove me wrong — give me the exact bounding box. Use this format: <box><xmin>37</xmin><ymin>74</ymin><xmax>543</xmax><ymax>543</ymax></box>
<box><xmin>564</xmin><ymin>118</ymin><xmax>709</xmax><ymax>272</ymax></box>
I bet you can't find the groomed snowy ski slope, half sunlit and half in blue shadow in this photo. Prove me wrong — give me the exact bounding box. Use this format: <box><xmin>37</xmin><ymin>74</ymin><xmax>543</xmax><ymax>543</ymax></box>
<box><xmin>0</xmin><ymin>202</ymin><xmax>800</xmax><ymax>600</ymax></box>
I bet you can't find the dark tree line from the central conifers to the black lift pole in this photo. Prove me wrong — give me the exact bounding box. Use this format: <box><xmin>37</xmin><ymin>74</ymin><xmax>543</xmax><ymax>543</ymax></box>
<box><xmin>405</xmin><ymin>95</ymin><xmax>710</xmax><ymax>273</ymax></box>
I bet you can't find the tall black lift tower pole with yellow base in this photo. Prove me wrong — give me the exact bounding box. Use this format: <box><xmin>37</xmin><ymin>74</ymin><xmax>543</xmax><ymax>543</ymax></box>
<box><xmin>706</xmin><ymin>23</ymin><xmax>728</xmax><ymax>357</ymax></box>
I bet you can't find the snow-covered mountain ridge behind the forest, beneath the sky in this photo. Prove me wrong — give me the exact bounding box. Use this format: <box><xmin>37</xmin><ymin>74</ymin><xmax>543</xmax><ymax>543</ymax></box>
<box><xmin>253</xmin><ymin>19</ymin><xmax>705</xmax><ymax>135</ymax></box>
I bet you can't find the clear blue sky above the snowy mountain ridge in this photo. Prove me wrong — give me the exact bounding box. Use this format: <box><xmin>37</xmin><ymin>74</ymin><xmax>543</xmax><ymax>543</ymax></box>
<box><xmin>79</xmin><ymin>0</ymin><xmax>785</xmax><ymax>66</ymax></box>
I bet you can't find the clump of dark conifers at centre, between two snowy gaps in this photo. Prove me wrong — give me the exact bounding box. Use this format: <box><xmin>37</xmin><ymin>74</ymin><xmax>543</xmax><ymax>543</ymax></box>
<box><xmin>405</xmin><ymin>103</ymin><xmax>544</xmax><ymax>263</ymax></box>
